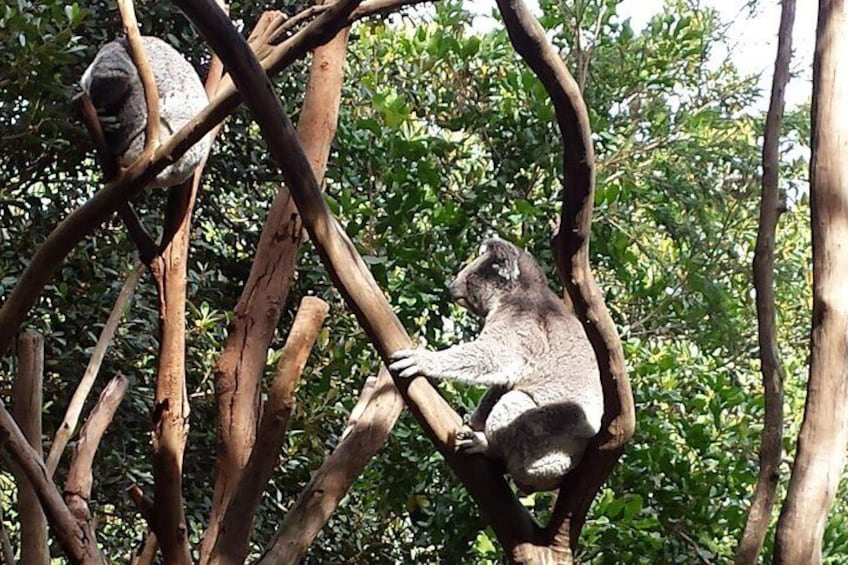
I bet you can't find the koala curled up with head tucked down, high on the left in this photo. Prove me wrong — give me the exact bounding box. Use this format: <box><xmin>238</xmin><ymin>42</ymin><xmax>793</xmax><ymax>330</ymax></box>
<box><xmin>80</xmin><ymin>36</ymin><xmax>210</xmax><ymax>187</ymax></box>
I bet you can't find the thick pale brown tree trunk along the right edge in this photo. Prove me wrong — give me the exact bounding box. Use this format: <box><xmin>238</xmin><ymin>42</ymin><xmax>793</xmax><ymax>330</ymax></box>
<box><xmin>774</xmin><ymin>0</ymin><xmax>848</xmax><ymax>565</ymax></box>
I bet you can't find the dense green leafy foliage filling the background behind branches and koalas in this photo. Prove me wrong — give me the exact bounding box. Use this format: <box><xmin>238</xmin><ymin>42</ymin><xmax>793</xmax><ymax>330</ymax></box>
<box><xmin>0</xmin><ymin>0</ymin><xmax>848</xmax><ymax>563</ymax></box>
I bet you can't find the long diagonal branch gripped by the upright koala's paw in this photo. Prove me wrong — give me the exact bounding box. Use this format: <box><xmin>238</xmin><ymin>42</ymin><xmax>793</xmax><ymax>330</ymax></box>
<box><xmin>176</xmin><ymin>0</ymin><xmax>538</xmax><ymax>553</ymax></box>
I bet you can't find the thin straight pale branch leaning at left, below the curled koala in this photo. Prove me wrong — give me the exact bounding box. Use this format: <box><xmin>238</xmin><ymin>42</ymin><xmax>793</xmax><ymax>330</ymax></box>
<box><xmin>47</xmin><ymin>263</ymin><xmax>144</xmax><ymax>478</ymax></box>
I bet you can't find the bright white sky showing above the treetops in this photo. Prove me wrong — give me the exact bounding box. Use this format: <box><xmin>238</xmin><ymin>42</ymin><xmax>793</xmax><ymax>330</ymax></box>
<box><xmin>468</xmin><ymin>0</ymin><xmax>818</xmax><ymax>110</ymax></box>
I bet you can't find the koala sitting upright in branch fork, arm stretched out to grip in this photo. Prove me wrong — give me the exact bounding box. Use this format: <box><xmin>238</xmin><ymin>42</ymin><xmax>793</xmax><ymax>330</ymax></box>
<box><xmin>390</xmin><ymin>239</ymin><xmax>604</xmax><ymax>492</ymax></box>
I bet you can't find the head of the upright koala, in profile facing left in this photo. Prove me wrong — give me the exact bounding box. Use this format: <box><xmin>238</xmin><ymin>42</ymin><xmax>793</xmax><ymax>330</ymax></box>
<box><xmin>448</xmin><ymin>238</ymin><xmax>547</xmax><ymax>318</ymax></box>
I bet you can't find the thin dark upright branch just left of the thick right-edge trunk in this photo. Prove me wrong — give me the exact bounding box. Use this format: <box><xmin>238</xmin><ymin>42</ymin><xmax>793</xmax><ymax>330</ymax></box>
<box><xmin>736</xmin><ymin>0</ymin><xmax>795</xmax><ymax>565</ymax></box>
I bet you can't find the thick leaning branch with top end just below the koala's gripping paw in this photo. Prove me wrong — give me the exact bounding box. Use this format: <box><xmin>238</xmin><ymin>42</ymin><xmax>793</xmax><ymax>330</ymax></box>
<box><xmin>259</xmin><ymin>366</ymin><xmax>403</xmax><ymax>565</ymax></box>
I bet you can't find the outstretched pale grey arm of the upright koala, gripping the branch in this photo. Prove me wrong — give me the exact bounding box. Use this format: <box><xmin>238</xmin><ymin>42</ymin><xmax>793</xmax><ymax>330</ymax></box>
<box><xmin>389</xmin><ymin>339</ymin><xmax>526</xmax><ymax>386</ymax></box>
